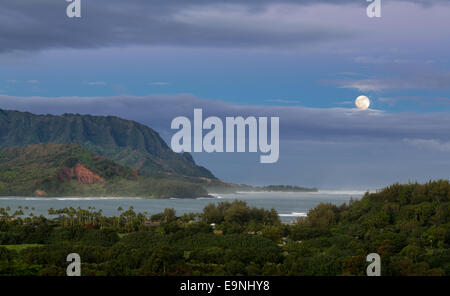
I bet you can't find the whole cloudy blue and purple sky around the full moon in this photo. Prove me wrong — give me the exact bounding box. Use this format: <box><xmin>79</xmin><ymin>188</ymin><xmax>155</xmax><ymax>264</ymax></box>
<box><xmin>0</xmin><ymin>0</ymin><xmax>450</xmax><ymax>190</ymax></box>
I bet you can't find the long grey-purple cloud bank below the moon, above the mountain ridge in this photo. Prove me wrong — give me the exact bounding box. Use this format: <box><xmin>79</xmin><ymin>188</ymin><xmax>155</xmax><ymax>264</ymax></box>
<box><xmin>0</xmin><ymin>94</ymin><xmax>450</xmax><ymax>141</ymax></box>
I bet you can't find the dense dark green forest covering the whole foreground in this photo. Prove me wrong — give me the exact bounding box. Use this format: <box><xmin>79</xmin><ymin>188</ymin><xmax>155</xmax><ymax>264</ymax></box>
<box><xmin>0</xmin><ymin>180</ymin><xmax>450</xmax><ymax>276</ymax></box>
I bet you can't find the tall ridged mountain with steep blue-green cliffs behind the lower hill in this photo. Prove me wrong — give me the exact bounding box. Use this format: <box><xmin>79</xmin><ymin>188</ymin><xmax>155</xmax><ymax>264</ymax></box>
<box><xmin>0</xmin><ymin>109</ymin><xmax>216</xmax><ymax>179</ymax></box>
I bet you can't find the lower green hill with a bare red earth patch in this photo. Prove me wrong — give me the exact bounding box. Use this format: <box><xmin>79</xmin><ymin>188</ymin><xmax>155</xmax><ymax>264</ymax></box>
<box><xmin>0</xmin><ymin>143</ymin><xmax>207</xmax><ymax>198</ymax></box>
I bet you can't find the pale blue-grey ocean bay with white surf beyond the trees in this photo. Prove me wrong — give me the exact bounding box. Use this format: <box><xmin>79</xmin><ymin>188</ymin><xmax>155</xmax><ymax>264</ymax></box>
<box><xmin>0</xmin><ymin>191</ymin><xmax>364</xmax><ymax>222</ymax></box>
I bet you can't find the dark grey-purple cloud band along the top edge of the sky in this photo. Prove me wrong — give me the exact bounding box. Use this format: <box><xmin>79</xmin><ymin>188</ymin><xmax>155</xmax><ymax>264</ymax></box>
<box><xmin>0</xmin><ymin>0</ymin><xmax>442</xmax><ymax>53</ymax></box>
